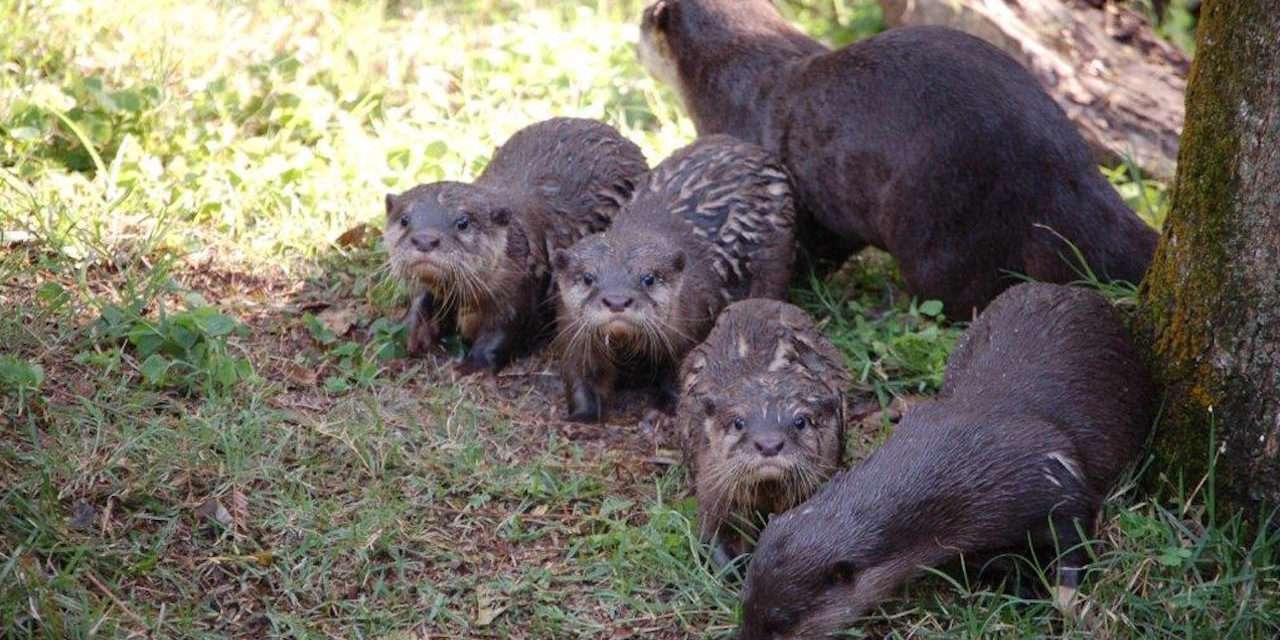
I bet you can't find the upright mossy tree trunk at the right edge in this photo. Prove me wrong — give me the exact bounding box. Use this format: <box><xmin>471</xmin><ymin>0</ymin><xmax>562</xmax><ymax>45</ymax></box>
<box><xmin>1140</xmin><ymin>0</ymin><xmax>1280</xmax><ymax>517</ymax></box>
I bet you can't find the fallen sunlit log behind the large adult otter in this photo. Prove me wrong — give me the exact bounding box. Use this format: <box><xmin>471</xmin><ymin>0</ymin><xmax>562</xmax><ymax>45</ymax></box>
<box><xmin>879</xmin><ymin>0</ymin><xmax>1188</xmax><ymax>180</ymax></box>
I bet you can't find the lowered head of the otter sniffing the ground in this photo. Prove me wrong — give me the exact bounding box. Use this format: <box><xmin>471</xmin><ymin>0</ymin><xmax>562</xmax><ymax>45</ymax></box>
<box><xmin>737</xmin><ymin>504</ymin><xmax>916</xmax><ymax>640</ymax></box>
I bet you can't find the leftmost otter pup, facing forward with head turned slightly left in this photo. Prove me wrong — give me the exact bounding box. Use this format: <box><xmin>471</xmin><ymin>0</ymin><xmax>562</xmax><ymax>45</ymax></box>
<box><xmin>384</xmin><ymin>118</ymin><xmax>648</xmax><ymax>372</ymax></box>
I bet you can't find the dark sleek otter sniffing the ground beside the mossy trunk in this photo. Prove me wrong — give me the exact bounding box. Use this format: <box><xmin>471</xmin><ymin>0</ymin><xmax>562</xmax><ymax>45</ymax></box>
<box><xmin>739</xmin><ymin>284</ymin><xmax>1153</xmax><ymax>640</ymax></box>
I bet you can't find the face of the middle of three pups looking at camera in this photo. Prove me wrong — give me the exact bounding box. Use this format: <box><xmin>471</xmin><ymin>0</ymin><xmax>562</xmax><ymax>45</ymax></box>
<box><xmin>553</xmin><ymin>233</ymin><xmax>685</xmax><ymax>357</ymax></box>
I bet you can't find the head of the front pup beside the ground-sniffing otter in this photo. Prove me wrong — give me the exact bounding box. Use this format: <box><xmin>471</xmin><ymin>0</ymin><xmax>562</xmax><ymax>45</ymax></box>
<box><xmin>699</xmin><ymin>372</ymin><xmax>844</xmax><ymax>521</ymax></box>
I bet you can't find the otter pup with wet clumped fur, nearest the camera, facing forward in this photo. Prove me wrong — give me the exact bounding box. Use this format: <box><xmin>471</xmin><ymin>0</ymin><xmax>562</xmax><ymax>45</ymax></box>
<box><xmin>676</xmin><ymin>300</ymin><xmax>849</xmax><ymax>566</ymax></box>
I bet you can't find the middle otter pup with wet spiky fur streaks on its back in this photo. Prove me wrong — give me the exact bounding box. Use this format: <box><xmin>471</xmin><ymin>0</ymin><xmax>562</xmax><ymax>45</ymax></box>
<box><xmin>554</xmin><ymin>136</ymin><xmax>795</xmax><ymax>421</ymax></box>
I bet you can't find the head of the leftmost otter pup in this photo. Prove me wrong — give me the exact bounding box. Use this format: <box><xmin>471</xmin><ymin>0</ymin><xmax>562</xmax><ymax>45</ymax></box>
<box><xmin>383</xmin><ymin>182</ymin><xmax>512</xmax><ymax>306</ymax></box>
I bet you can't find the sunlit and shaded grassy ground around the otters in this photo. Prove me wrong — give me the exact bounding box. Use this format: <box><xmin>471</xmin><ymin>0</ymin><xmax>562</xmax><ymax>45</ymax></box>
<box><xmin>0</xmin><ymin>0</ymin><xmax>1280</xmax><ymax>639</ymax></box>
